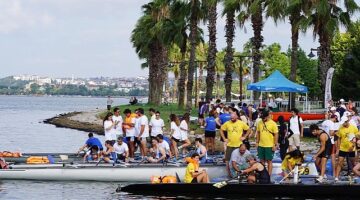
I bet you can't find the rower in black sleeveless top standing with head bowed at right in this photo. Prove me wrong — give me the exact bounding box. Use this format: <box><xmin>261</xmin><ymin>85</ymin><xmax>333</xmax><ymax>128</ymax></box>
<box><xmin>310</xmin><ymin>124</ymin><xmax>332</xmax><ymax>183</ymax></box>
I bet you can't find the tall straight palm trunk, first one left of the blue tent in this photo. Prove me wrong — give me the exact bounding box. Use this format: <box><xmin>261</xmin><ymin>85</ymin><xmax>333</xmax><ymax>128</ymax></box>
<box><xmin>224</xmin><ymin>12</ymin><xmax>235</xmax><ymax>102</ymax></box>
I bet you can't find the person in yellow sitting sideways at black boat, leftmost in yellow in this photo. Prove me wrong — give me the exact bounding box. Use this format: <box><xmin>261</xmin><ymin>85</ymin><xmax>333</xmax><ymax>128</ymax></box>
<box><xmin>184</xmin><ymin>153</ymin><xmax>210</xmax><ymax>183</ymax></box>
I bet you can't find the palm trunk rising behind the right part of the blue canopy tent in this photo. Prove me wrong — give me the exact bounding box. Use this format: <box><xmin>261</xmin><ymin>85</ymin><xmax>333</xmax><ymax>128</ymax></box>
<box><xmin>288</xmin><ymin>13</ymin><xmax>300</xmax><ymax>110</ymax></box>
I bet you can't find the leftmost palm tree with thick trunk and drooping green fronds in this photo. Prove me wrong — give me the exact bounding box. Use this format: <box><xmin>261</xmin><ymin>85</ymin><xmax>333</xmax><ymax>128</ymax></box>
<box><xmin>131</xmin><ymin>0</ymin><xmax>170</xmax><ymax>105</ymax></box>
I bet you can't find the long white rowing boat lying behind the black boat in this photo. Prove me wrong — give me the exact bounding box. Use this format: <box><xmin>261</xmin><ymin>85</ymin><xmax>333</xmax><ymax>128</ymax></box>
<box><xmin>0</xmin><ymin>163</ymin><xmax>318</xmax><ymax>182</ymax></box>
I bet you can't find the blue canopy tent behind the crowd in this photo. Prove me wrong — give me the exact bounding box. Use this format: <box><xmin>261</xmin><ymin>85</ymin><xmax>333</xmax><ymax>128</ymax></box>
<box><xmin>247</xmin><ymin>70</ymin><xmax>308</xmax><ymax>110</ymax></box>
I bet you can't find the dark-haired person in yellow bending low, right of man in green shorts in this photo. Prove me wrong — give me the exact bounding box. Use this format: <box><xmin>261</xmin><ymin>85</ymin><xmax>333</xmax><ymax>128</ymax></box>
<box><xmin>281</xmin><ymin>146</ymin><xmax>304</xmax><ymax>180</ymax></box>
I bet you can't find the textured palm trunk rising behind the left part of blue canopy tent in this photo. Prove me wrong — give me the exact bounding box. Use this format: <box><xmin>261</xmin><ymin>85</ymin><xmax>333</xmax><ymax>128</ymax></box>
<box><xmin>251</xmin><ymin>10</ymin><xmax>264</xmax><ymax>99</ymax></box>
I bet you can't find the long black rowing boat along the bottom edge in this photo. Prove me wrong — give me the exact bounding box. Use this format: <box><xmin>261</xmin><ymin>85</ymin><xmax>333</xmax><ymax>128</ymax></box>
<box><xmin>117</xmin><ymin>182</ymin><xmax>360</xmax><ymax>199</ymax></box>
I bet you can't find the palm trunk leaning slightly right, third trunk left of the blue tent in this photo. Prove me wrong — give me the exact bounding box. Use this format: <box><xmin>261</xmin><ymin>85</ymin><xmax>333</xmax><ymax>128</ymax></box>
<box><xmin>186</xmin><ymin>0</ymin><xmax>199</xmax><ymax>112</ymax></box>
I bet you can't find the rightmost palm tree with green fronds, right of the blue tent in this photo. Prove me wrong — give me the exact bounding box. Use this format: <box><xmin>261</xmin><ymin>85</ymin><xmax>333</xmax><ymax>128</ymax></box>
<box><xmin>303</xmin><ymin>0</ymin><xmax>359</xmax><ymax>96</ymax></box>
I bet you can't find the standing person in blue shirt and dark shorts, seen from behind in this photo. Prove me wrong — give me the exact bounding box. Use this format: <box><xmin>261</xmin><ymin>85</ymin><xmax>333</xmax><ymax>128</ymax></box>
<box><xmin>205</xmin><ymin>110</ymin><xmax>216</xmax><ymax>153</ymax></box>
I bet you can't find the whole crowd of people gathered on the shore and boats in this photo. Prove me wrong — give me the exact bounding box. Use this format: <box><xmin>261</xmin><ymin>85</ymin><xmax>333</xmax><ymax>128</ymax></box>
<box><xmin>79</xmin><ymin>97</ymin><xmax>360</xmax><ymax>183</ymax></box>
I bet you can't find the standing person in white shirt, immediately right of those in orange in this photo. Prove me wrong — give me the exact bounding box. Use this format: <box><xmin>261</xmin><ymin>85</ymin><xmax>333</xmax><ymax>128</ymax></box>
<box><xmin>135</xmin><ymin>108</ymin><xmax>149</xmax><ymax>158</ymax></box>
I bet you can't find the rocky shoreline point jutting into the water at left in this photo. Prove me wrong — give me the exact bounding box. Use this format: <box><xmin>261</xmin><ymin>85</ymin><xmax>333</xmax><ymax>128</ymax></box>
<box><xmin>43</xmin><ymin>111</ymin><xmax>104</xmax><ymax>135</ymax></box>
